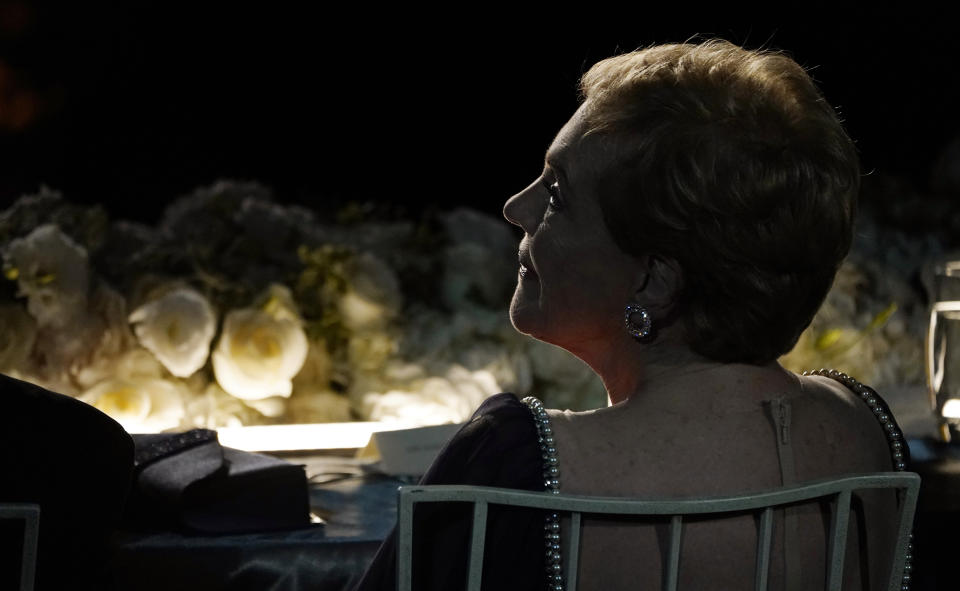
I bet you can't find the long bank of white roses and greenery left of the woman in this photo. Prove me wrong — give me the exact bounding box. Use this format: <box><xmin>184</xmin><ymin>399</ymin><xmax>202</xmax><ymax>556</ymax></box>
<box><xmin>0</xmin><ymin>181</ymin><xmax>605</xmax><ymax>432</ymax></box>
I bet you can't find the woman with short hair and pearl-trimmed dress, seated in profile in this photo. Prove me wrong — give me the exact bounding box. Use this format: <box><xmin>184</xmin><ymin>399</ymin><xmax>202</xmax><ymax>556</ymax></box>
<box><xmin>361</xmin><ymin>41</ymin><xmax>903</xmax><ymax>589</ymax></box>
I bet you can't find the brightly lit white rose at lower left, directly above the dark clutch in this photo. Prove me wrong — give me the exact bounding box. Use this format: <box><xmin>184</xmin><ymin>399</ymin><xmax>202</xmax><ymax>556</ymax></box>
<box><xmin>80</xmin><ymin>377</ymin><xmax>185</xmax><ymax>433</ymax></box>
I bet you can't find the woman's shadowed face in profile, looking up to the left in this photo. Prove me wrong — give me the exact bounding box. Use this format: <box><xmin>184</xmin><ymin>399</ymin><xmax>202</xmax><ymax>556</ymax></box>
<box><xmin>503</xmin><ymin>109</ymin><xmax>643</xmax><ymax>357</ymax></box>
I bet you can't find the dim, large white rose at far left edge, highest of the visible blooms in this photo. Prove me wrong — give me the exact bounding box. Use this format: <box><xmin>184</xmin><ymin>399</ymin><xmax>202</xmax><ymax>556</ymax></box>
<box><xmin>4</xmin><ymin>224</ymin><xmax>90</xmax><ymax>327</ymax></box>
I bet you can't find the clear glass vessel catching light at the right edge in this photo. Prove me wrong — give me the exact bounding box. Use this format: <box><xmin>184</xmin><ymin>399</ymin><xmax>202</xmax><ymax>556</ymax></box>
<box><xmin>926</xmin><ymin>261</ymin><xmax>960</xmax><ymax>441</ymax></box>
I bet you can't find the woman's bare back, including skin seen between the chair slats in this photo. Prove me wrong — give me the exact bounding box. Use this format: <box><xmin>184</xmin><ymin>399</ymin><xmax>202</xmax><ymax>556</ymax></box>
<box><xmin>552</xmin><ymin>368</ymin><xmax>896</xmax><ymax>590</ymax></box>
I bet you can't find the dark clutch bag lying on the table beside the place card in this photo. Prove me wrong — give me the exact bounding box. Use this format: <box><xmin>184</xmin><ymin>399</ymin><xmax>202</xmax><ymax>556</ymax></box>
<box><xmin>125</xmin><ymin>429</ymin><xmax>310</xmax><ymax>534</ymax></box>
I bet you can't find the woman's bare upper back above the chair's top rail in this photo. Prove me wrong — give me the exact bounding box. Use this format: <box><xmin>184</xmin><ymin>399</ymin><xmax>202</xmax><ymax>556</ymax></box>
<box><xmin>549</xmin><ymin>376</ymin><xmax>893</xmax><ymax>496</ymax></box>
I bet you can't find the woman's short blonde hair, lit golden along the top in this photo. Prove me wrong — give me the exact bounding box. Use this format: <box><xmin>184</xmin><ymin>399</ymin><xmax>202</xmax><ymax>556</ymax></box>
<box><xmin>581</xmin><ymin>40</ymin><xmax>859</xmax><ymax>363</ymax></box>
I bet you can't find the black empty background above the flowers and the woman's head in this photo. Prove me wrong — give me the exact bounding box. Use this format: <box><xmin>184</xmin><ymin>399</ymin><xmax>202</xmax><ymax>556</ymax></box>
<box><xmin>0</xmin><ymin>5</ymin><xmax>960</xmax><ymax>222</ymax></box>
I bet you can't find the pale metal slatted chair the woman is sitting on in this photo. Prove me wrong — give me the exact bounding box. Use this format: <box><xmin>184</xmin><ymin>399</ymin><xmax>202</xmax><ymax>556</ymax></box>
<box><xmin>397</xmin><ymin>472</ymin><xmax>920</xmax><ymax>591</ymax></box>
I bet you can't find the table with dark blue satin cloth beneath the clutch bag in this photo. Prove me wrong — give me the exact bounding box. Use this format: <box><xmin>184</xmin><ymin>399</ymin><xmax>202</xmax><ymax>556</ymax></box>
<box><xmin>113</xmin><ymin>457</ymin><xmax>404</xmax><ymax>591</ymax></box>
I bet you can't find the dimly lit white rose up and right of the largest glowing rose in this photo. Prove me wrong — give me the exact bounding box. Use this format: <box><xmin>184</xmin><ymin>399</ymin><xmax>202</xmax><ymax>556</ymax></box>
<box><xmin>339</xmin><ymin>253</ymin><xmax>403</xmax><ymax>330</ymax></box>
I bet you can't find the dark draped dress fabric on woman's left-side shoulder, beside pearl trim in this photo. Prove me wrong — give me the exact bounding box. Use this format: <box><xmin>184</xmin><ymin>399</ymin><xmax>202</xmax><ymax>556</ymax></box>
<box><xmin>356</xmin><ymin>394</ymin><xmax>546</xmax><ymax>591</ymax></box>
